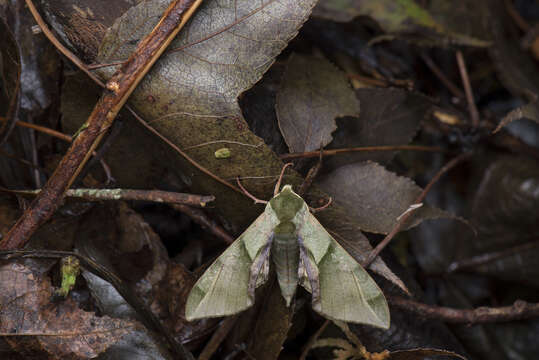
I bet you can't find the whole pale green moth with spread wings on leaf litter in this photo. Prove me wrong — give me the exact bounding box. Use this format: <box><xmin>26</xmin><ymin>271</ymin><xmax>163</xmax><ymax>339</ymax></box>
<box><xmin>185</xmin><ymin>185</ymin><xmax>389</xmax><ymax>329</ymax></box>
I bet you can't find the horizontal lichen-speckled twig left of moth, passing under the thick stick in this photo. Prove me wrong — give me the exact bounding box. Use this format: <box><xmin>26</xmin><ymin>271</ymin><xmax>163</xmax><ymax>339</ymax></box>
<box><xmin>0</xmin><ymin>188</ymin><xmax>215</xmax><ymax>207</ymax></box>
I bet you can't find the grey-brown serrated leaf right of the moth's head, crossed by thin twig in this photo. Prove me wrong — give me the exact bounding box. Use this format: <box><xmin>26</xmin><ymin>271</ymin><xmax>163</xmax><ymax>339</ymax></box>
<box><xmin>319</xmin><ymin>162</ymin><xmax>454</xmax><ymax>234</ymax></box>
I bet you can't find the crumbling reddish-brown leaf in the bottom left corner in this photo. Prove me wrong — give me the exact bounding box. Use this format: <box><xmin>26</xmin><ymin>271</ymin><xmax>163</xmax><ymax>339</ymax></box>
<box><xmin>0</xmin><ymin>262</ymin><xmax>140</xmax><ymax>359</ymax></box>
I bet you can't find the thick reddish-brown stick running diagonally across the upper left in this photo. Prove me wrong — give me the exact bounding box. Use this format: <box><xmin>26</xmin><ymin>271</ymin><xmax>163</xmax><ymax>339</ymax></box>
<box><xmin>0</xmin><ymin>0</ymin><xmax>202</xmax><ymax>249</ymax></box>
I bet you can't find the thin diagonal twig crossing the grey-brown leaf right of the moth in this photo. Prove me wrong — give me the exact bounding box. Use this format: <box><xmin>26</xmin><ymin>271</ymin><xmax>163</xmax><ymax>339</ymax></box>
<box><xmin>362</xmin><ymin>153</ymin><xmax>472</xmax><ymax>268</ymax></box>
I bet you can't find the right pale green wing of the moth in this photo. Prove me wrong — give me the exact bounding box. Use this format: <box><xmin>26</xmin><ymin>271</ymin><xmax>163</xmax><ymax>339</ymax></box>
<box><xmin>300</xmin><ymin>214</ymin><xmax>390</xmax><ymax>329</ymax></box>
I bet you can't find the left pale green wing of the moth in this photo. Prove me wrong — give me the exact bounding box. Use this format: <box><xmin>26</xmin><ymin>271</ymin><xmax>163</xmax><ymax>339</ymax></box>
<box><xmin>185</xmin><ymin>207</ymin><xmax>278</xmax><ymax>321</ymax></box>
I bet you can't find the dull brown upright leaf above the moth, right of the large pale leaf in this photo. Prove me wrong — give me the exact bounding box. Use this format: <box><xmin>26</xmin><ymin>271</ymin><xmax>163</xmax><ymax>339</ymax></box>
<box><xmin>275</xmin><ymin>54</ymin><xmax>359</xmax><ymax>152</ymax></box>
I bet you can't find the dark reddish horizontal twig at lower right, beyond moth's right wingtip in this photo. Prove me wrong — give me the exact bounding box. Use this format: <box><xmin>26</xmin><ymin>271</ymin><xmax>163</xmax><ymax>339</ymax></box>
<box><xmin>387</xmin><ymin>296</ymin><xmax>539</xmax><ymax>324</ymax></box>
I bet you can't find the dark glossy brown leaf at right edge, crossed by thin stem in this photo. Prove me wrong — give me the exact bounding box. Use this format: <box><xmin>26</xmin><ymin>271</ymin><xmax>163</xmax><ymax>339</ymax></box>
<box><xmin>462</xmin><ymin>157</ymin><xmax>539</xmax><ymax>286</ymax></box>
